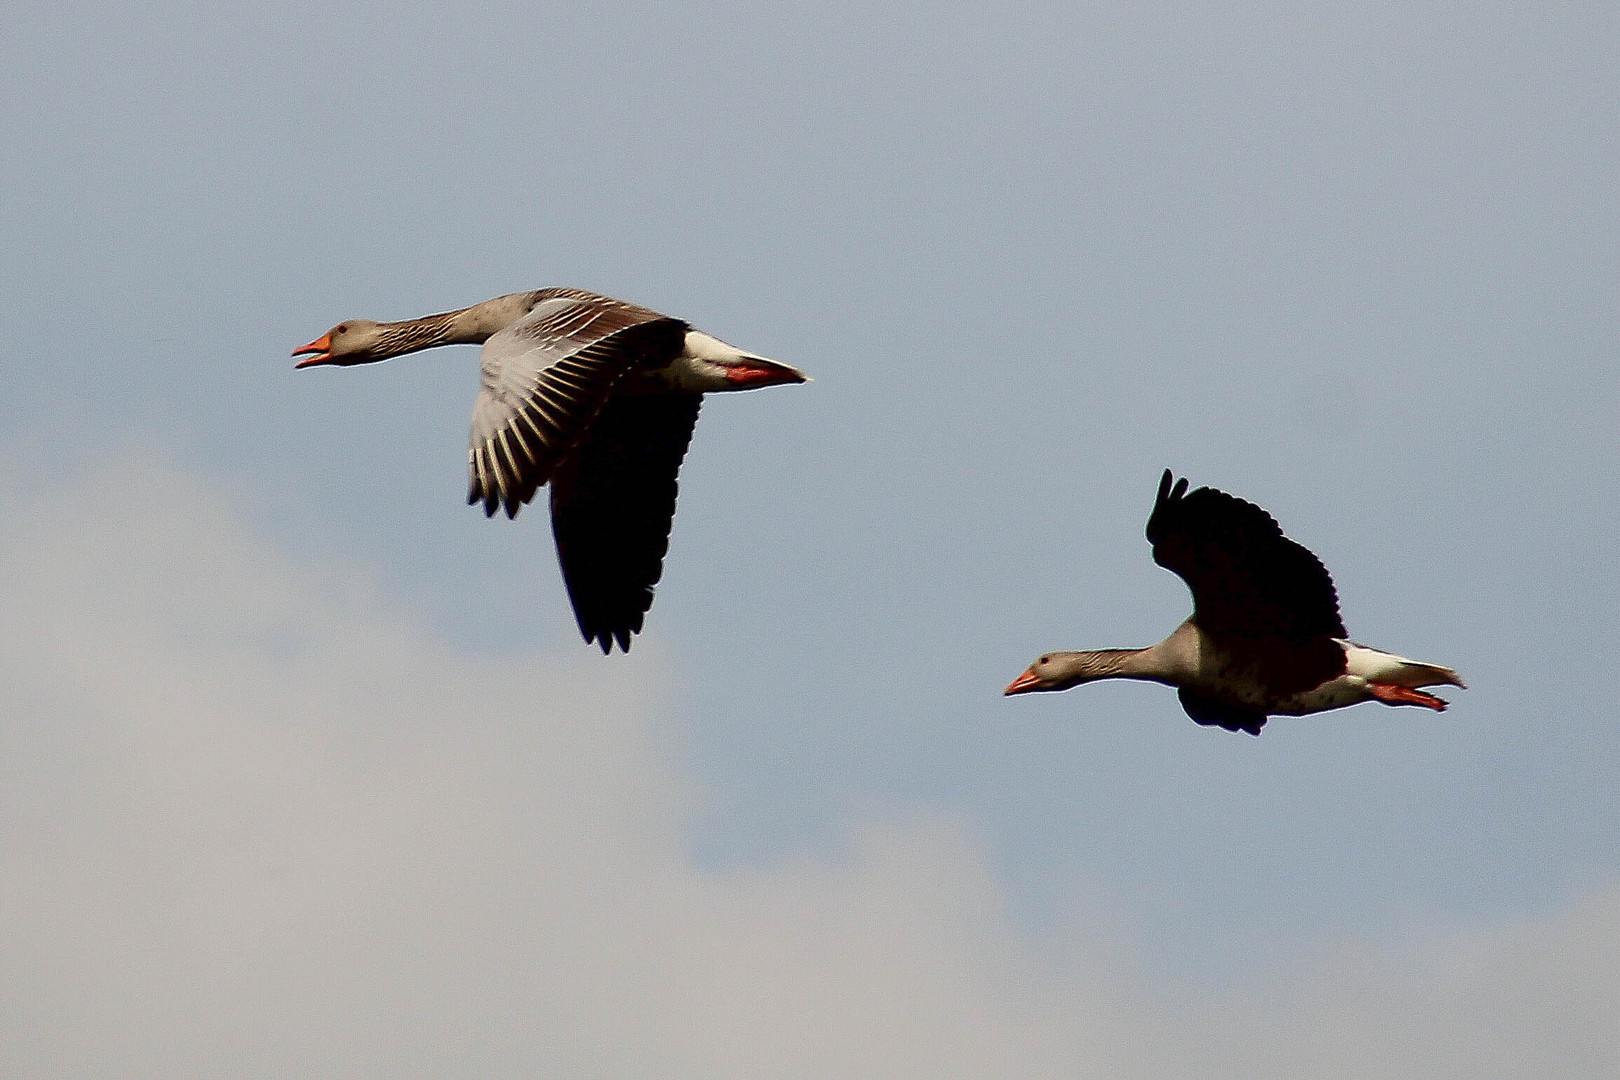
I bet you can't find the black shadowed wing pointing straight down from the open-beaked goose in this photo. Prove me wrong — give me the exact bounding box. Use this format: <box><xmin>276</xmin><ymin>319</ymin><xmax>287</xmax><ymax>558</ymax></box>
<box><xmin>551</xmin><ymin>393</ymin><xmax>703</xmax><ymax>653</ymax></box>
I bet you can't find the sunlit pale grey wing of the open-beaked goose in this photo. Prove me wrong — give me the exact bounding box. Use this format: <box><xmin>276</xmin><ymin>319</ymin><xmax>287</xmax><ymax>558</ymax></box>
<box><xmin>467</xmin><ymin>290</ymin><xmax>687</xmax><ymax>518</ymax></box>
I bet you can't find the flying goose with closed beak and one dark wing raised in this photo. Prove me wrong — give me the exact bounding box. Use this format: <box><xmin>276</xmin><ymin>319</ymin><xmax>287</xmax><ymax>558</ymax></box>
<box><xmin>1004</xmin><ymin>470</ymin><xmax>1463</xmax><ymax>735</ymax></box>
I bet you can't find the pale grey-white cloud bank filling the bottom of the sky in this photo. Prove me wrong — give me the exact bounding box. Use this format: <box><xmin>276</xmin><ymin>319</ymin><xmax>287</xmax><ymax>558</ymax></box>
<box><xmin>0</xmin><ymin>457</ymin><xmax>1620</xmax><ymax>1078</ymax></box>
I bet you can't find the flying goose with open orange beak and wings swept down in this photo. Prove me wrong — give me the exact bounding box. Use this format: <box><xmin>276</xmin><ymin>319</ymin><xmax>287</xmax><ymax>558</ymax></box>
<box><xmin>293</xmin><ymin>288</ymin><xmax>805</xmax><ymax>654</ymax></box>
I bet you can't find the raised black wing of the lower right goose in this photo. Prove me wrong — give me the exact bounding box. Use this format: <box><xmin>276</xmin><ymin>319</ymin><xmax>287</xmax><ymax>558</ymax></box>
<box><xmin>1147</xmin><ymin>470</ymin><xmax>1346</xmax><ymax>641</ymax></box>
